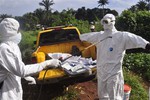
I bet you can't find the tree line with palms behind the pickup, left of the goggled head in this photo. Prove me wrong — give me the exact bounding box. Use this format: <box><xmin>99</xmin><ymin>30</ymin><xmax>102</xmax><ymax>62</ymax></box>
<box><xmin>0</xmin><ymin>0</ymin><xmax>118</xmax><ymax>30</ymax></box>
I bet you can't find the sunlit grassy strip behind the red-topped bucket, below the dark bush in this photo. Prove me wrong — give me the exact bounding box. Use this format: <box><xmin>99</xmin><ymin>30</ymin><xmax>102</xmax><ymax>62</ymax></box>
<box><xmin>124</xmin><ymin>68</ymin><xmax>148</xmax><ymax>100</ymax></box>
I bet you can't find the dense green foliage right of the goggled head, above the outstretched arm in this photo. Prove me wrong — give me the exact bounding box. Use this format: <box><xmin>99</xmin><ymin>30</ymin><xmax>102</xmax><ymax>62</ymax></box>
<box><xmin>116</xmin><ymin>11</ymin><xmax>150</xmax><ymax>41</ymax></box>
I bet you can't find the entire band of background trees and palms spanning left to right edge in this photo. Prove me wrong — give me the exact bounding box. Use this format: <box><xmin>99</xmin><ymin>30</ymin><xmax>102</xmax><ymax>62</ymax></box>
<box><xmin>0</xmin><ymin>0</ymin><xmax>150</xmax><ymax>35</ymax></box>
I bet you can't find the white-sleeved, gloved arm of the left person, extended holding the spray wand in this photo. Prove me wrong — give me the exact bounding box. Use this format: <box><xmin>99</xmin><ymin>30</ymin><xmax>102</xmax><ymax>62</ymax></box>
<box><xmin>0</xmin><ymin>47</ymin><xmax>60</xmax><ymax>77</ymax></box>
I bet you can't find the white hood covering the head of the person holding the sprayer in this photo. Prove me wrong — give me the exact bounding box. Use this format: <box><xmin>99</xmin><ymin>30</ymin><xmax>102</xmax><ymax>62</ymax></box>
<box><xmin>0</xmin><ymin>18</ymin><xmax>21</xmax><ymax>44</ymax></box>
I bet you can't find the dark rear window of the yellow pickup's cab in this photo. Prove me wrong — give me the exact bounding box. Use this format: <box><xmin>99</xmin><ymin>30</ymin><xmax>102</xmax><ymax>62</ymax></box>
<box><xmin>39</xmin><ymin>29</ymin><xmax>79</xmax><ymax>46</ymax></box>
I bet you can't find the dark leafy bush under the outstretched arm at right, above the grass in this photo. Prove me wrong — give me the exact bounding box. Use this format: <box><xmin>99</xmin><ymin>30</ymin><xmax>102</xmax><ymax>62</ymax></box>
<box><xmin>123</xmin><ymin>53</ymin><xmax>150</xmax><ymax>82</ymax></box>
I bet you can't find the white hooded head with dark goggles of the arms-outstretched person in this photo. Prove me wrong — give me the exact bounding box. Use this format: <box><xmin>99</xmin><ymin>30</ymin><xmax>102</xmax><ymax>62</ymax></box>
<box><xmin>101</xmin><ymin>14</ymin><xmax>117</xmax><ymax>31</ymax></box>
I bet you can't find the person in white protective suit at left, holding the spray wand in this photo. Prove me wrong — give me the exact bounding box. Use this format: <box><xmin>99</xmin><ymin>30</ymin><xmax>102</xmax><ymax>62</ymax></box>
<box><xmin>0</xmin><ymin>18</ymin><xmax>60</xmax><ymax>100</ymax></box>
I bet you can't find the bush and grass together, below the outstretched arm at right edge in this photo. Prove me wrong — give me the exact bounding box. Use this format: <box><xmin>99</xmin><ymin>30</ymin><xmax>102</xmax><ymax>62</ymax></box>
<box><xmin>123</xmin><ymin>53</ymin><xmax>150</xmax><ymax>100</ymax></box>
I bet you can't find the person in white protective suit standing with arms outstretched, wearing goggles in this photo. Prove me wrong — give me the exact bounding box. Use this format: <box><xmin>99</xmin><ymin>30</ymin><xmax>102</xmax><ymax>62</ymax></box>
<box><xmin>80</xmin><ymin>14</ymin><xmax>150</xmax><ymax>100</ymax></box>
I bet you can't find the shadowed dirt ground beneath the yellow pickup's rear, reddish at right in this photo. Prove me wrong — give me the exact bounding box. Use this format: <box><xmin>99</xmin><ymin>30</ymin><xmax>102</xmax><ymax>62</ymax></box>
<box><xmin>22</xmin><ymin>76</ymin><xmax>97</xmax><ymax>100</ymax></box>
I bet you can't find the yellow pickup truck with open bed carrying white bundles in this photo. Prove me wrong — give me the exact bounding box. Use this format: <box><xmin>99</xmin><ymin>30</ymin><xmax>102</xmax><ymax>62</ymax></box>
<box><xmin>32</xmin><ymin>26</ymin><xmax>96</xmax><ymax>83</ymax></box>
